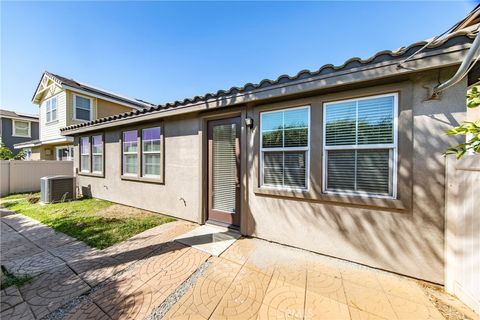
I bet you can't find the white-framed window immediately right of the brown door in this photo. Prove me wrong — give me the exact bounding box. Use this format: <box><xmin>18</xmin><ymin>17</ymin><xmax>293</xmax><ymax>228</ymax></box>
<box><xmin>260</xmin><ymin>107</ymin><xmax>310</xmax><ymax>189</ymax></box>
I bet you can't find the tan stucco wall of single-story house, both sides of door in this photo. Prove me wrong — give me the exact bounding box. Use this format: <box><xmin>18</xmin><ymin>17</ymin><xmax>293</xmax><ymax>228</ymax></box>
<box><xmin>75</xmin><ymin>69</ymin><xmax>466</xmax><ymax>283</ymax></box>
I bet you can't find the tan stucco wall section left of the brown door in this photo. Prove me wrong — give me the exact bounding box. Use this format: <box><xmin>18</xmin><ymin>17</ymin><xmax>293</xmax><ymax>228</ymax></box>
<box><xmin>74</xmin><ymin>117</ymin><xmax>200</xmax><ymax>221</ymax></box>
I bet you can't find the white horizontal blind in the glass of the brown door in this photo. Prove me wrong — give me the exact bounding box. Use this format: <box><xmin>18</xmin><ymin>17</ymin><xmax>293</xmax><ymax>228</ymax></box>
<box><xmin>212</xmin><ymin>123</ymin><xmax>237</xmax><ymax>212</ymax></box>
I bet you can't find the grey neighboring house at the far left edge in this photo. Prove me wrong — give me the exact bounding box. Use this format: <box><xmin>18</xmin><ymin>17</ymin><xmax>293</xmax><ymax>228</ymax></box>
<box><xmin>0</xmin><ymin>109</ymin><xmax>38</xmax><ymax>156</ymax></box>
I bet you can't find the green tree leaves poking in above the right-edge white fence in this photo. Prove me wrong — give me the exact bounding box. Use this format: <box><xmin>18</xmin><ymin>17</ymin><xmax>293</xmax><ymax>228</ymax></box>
<box><xmin>445</xmin><ymin>86</ymin><xmax>480</xmax><ymax>159</ymax></box>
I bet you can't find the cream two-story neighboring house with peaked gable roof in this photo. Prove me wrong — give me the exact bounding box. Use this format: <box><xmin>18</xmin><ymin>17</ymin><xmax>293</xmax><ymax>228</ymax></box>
<box><xmin>15</xmin><ymin>72</ymin><xmax>152</xmax><ymax>160</ymax></box>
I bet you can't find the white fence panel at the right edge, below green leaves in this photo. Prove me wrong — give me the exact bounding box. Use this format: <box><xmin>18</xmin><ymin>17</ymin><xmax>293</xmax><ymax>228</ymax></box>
<box><xmin>445</xmin><ymin>155</ymin><xmax>480</xmax><ymax>313</ymax></box>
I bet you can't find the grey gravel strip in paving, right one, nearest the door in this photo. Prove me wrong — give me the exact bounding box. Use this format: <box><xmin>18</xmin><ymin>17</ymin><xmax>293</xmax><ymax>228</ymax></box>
<box><xmin>145</xmin><ymin>259</ymin><xmax>212</xmax><ymax>320</ymax></box>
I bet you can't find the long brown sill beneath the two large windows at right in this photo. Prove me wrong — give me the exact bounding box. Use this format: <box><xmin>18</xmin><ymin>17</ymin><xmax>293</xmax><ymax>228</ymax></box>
<box><xmin>253</xmin><ymin>187</ymin><xmax>411</xmax><ymax>211</ymax></box>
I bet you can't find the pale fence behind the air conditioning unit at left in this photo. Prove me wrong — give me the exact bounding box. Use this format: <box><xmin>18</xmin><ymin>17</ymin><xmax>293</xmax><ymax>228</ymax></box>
<box><xmin>0</xmin><ymin>160</ymin><xmax>73</xmax><ymax>196</ymax></box>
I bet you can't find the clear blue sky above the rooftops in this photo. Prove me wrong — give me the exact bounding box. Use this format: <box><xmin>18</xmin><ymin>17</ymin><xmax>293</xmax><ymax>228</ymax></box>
<box><xmin>0</xmin><ymin>1</ymin><xmax>475</xmax><ymax>113</ymax></box>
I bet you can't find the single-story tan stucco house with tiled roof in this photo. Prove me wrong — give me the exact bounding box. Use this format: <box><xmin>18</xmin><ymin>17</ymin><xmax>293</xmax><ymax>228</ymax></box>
<box><xmin>62</xmin><ymin>24</ymin><xmax>477</xmax><ymax>283</ymax></box>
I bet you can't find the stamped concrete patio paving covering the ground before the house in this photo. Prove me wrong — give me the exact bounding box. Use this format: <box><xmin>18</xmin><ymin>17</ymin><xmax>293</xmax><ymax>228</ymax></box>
<box><xmin>0</xmin><ymin>206</ymin><xmax>476</xmax><ymax>319</ymax></box>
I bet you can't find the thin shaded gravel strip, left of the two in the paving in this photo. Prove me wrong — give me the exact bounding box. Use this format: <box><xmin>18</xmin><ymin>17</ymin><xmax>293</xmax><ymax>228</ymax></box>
<box><xmin>42</xmin><ymin>242</ymin><xmax>182</xmax><ymax>320</ymax></box>
